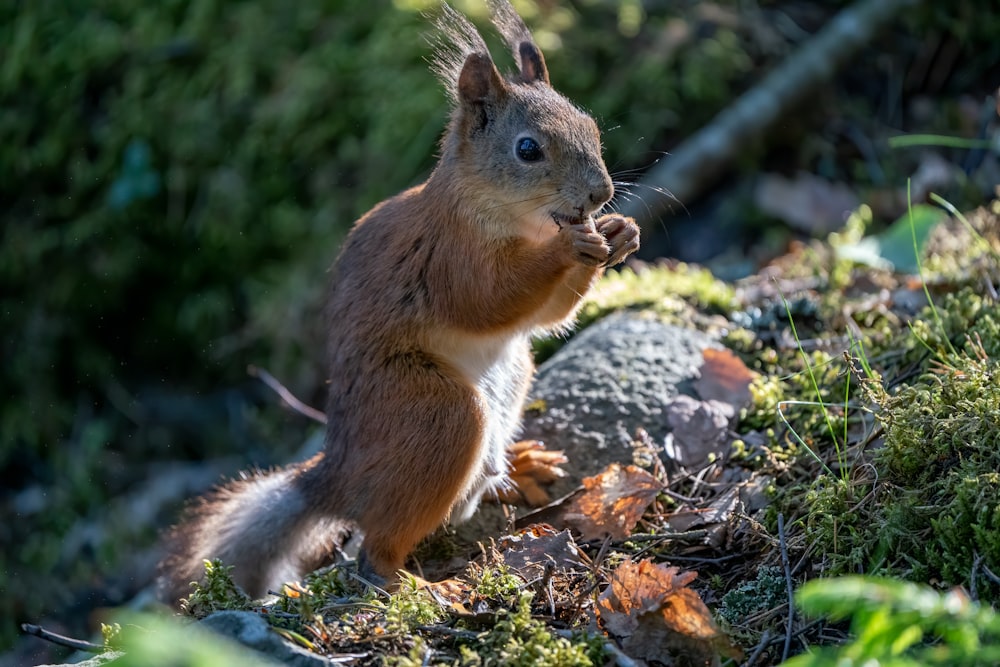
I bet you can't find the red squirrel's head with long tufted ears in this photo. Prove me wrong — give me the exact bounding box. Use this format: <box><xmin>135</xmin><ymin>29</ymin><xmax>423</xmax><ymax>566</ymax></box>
<box><xmin>434</xmin><ymin>0</ymin><xmax>614</xmax><ymax>230</ymax></box>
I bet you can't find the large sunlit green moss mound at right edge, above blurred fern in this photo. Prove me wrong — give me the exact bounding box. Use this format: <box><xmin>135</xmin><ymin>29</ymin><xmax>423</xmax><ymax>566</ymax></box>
<box><xmin>803</xmin><ymin>291</ymin><xmax>1000</xmax><ymax>601</ymax></box>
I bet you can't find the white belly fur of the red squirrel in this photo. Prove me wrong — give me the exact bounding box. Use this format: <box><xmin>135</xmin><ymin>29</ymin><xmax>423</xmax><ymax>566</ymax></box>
<box><xmin>435</xmin><ymin>333</ymin><xmax>533</xmax><ymax>523</ymax></box>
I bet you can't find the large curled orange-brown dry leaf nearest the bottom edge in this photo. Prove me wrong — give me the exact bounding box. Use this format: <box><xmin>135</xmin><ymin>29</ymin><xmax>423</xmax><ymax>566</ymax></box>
<box><xmin>597</xmin><ymin>560</ymin><xmax>733</xmax><ymax>666</ymax></box>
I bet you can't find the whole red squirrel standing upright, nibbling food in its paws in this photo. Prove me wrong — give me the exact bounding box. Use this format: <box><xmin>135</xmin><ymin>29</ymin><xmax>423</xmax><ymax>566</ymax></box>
<box><xmin>161</xmin><ymin>0</ymin><xmax>639</xmax><ymax>604</ymax></box>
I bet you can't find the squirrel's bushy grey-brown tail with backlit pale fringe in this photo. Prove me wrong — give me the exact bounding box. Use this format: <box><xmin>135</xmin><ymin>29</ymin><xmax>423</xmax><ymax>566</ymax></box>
<box><xmin>158</xmin><ymin>463</ymin><xmax>346</xmax><ymax>606</ymax></box>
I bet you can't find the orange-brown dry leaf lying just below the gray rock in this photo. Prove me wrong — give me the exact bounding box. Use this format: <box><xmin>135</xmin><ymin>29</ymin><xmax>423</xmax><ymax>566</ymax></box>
<box><xmin>563</xmin><ymin>463</ymin><xmax>663</xmax><ymax>540</ymax></box>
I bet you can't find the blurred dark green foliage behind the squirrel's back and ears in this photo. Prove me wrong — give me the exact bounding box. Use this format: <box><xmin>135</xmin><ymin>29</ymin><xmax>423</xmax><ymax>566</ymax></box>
<box><xmin>0</xmin><ymin>0</ymin><xmax>748</xmax><ymax>481</ymax></box>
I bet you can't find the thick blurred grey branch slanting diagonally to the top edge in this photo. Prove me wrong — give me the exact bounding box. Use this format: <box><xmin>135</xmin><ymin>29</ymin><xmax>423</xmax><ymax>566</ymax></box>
<box><xmin>621</xmin><ymin>0</ymin><xmax>919</xmax><ymax>228</ymax></box>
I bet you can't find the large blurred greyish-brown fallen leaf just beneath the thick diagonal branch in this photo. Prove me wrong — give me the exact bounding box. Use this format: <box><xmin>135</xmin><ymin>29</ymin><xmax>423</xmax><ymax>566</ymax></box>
<box><xmin>754</xmin><ymin>172</ymin><xmax>861</xmax><ymax>236</ymax></box>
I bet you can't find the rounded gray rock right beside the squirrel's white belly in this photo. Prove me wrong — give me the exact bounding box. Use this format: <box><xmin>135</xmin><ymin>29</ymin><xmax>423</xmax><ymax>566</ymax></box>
<box><xmin>522</xmin><ymin>312</ymin><xmax>719</xmax><ymax>495</ymax></box>
